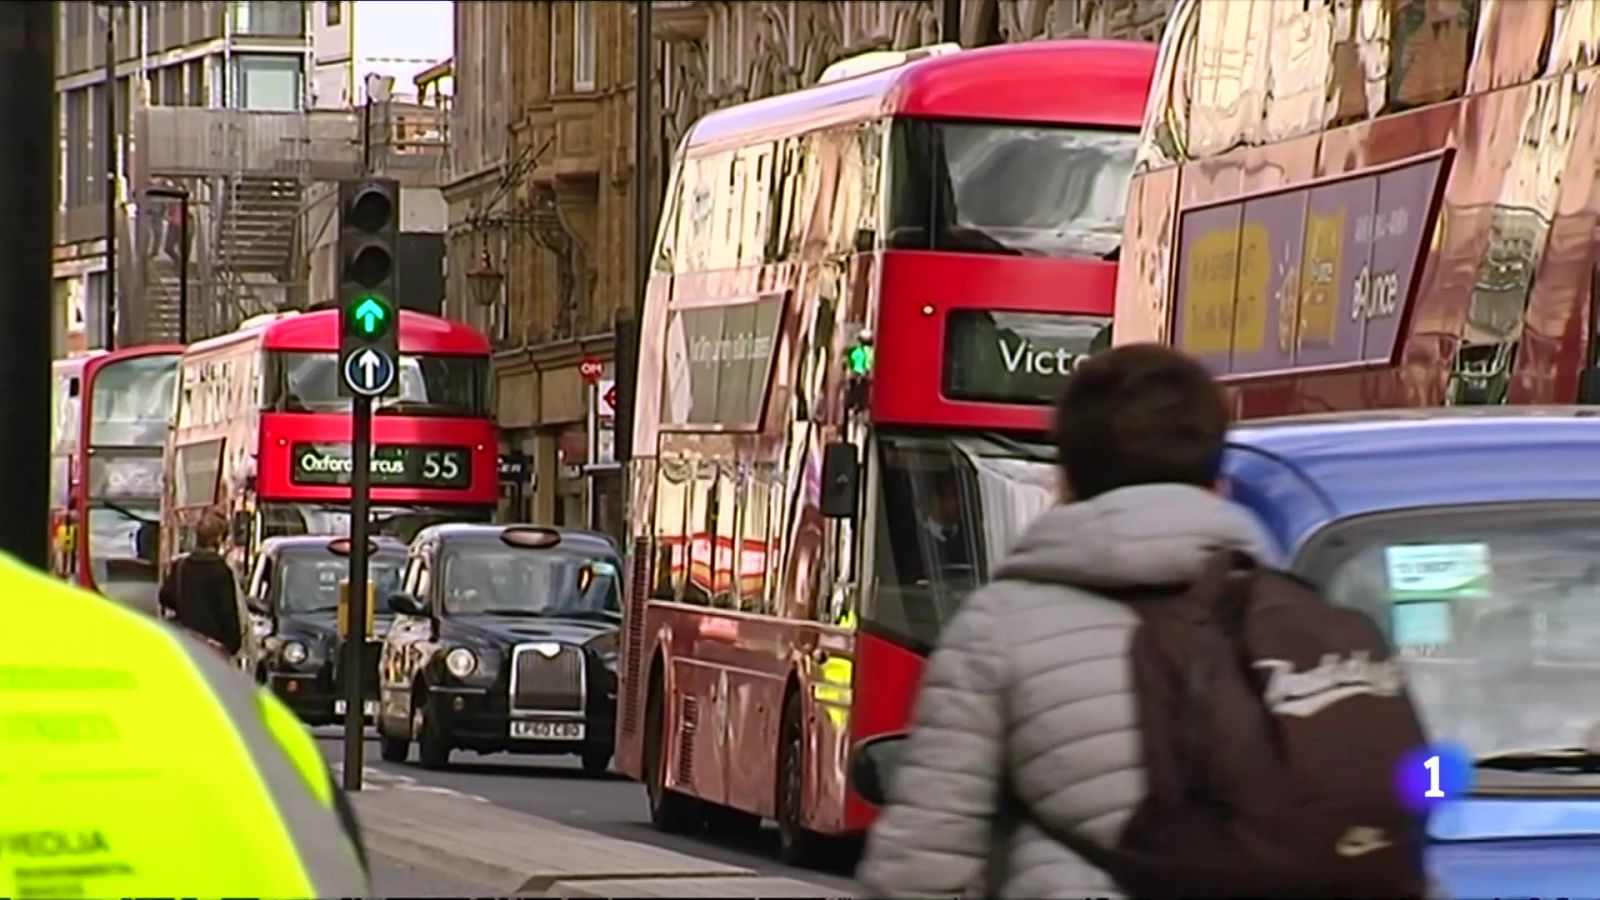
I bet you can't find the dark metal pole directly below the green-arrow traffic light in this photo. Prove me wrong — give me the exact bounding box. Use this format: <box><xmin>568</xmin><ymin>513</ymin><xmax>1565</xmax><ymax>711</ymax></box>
<box><xmin>344</xmin><ymin>396</ymin><xmax>373</xmax><ymax>791</ymax></box>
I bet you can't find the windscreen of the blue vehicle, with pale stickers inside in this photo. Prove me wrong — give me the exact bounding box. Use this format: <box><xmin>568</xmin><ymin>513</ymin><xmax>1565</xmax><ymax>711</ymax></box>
<box><xmin>1298</xmin><ymin>503</ymin><xmax>1600</xmax><ymax>757</ymax></box>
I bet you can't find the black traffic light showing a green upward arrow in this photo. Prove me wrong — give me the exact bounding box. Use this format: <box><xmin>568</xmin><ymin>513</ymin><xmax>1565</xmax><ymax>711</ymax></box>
<box><xmin>339</xmin><ymin>178</ymin><xmax>400</xmax><ymax>397</ymax></box>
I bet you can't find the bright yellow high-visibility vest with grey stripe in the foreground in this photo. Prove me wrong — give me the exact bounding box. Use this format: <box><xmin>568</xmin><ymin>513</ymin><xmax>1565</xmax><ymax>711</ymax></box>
<box><xmin>0</xmin><ymin>556</ymin><xmax>368</xmax><ymax>900</ymax></box>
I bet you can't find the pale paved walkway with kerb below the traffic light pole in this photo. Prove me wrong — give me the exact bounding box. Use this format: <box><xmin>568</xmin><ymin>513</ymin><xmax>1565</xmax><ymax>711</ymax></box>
<box><xmin>350</xmin><ymin>781</ymin><xmax>838</xmax><ymax>898</ymax></box>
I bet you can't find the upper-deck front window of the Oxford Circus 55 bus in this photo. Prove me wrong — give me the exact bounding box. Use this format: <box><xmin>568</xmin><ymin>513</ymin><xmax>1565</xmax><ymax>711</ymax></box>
<box><xmin>266</xmin><ymin>351</ymin><xmax>490</xmax><ymax>418</ymax></box>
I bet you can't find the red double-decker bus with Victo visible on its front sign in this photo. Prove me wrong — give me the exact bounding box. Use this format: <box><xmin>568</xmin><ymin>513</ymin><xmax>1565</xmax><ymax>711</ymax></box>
<box><xmin>616</xmin><ymin>42</ymin><xmax>1155</xmax><ymax>862</ymax></box>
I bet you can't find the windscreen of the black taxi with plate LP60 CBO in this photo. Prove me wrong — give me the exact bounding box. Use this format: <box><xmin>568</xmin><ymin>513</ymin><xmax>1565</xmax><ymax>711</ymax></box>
<box><xmin>443</xmin><ymin>541</ymin><xmax>622</xmax><ymax>618</ymax></box>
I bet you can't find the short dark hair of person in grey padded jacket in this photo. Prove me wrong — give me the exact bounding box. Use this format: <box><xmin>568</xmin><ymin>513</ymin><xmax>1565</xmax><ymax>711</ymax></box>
<box><xmin>1056</xmin><ymin>344</ymin><xmax>1229</xmax><ymax>500</ymax></box>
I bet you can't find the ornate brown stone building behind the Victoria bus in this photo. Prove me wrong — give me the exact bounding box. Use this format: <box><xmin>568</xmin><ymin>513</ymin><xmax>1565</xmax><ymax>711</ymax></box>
<box><xmin>446</xmin><ymin>0</ymin><xmax>1171</xmax><ymax>533</ymax></box>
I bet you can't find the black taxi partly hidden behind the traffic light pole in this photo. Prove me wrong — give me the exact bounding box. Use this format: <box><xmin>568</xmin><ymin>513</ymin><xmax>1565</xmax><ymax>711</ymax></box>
<box><xmin>245</xmin><ymin>535</ymin><xmax>406</xmax><ymax>725</ymax></box>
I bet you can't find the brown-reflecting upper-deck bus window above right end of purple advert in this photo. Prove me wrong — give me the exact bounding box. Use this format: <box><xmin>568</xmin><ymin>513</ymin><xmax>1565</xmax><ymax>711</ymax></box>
<box><xmin>1384</xmin><ymin>0</ymin><xmax>1478</xmax><ymax>114</ymax></box>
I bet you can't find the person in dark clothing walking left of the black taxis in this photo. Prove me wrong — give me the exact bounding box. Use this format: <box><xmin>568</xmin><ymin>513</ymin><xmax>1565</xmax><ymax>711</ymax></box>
<box><xmin>160</xmin><ymin>512</ymin><xmax>245</xmax><ymax>658</ymax></box>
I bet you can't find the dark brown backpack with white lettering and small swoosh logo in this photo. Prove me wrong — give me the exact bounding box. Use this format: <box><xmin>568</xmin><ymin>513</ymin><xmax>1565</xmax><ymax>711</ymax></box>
<box><xmin>1011</xmin><ymin>551</ymin><xmax>1427</xmax><ymax>898</ymax></box>
